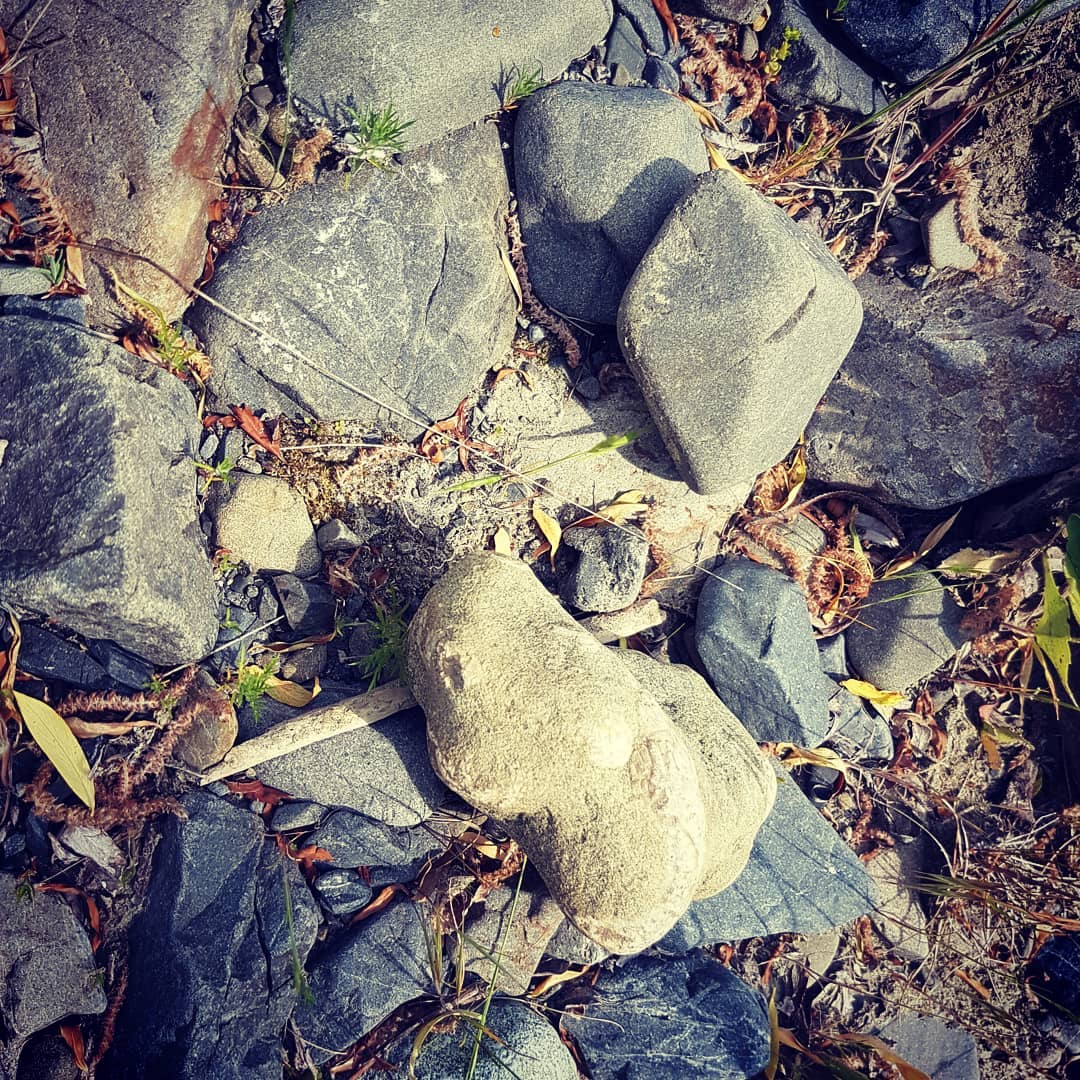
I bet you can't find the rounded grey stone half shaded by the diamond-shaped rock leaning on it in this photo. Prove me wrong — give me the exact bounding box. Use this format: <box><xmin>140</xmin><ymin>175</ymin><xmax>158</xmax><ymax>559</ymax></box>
<box><xmin>514</xmin><ymin>82</ymin><xmax>708</xmax><ymax>323</ymax></box>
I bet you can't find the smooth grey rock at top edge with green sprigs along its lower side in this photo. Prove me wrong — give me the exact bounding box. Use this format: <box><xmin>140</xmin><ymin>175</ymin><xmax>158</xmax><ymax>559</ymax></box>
<box><xmin>292</xmin><ymin>0</ymin><xmax>611</xmax><ymax>149</ymax></box>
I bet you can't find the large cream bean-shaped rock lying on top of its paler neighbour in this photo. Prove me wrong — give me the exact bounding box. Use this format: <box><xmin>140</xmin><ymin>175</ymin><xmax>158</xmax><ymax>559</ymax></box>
<box><xmin>407</xmin><ymin>554</ymin><xmax>767</xmax><ymax>953</ymax></box>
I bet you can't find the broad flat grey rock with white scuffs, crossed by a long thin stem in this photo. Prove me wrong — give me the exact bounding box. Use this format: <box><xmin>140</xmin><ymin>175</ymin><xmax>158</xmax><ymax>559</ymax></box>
<box><xmin>192</xmin><ymin>124</ymin><xmax>514</xmax><ymax>427</ymax></box>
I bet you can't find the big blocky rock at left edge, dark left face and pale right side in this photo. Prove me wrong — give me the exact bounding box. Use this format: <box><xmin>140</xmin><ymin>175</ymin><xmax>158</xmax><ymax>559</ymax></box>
<box><xmin>0</xmin><ymin>302</ymin><xmax>217</xmax><ymax>664</ymax></box>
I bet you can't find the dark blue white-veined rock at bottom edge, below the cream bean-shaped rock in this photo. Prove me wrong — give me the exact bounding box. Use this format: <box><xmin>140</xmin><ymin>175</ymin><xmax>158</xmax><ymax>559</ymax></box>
<box><xmin>563</xmin><ymin>953</ymin><xmax>769</xmax><ymax>1080</ymax></box>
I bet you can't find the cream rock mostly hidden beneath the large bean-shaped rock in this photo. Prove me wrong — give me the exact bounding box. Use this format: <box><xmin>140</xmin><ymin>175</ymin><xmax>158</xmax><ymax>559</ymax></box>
<box><xmin>616</xmin><ymin>649</ymin><xmax>777</xmax><ymax>899</ymax></box>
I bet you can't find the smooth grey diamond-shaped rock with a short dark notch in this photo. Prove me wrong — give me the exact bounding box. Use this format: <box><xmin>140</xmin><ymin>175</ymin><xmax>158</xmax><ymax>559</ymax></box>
<box><xmin>619</xmin><ymin>172</ymin><xmax>862</xmax><ymax>491</ymax></box>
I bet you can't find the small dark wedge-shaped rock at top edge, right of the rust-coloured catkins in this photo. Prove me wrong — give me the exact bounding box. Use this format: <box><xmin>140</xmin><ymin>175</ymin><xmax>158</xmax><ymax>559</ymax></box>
<box><xmin>761</xmin><ymin>0</ymin><xmax>888</xmax><ymax>116</ymax></box>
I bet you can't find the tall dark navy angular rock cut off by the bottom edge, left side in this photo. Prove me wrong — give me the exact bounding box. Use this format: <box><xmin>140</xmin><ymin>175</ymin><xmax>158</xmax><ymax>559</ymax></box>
<box><xmin>103</xmin><ymin>791</ymin><xmax>319</xmax><ymax>1080</ymax></box>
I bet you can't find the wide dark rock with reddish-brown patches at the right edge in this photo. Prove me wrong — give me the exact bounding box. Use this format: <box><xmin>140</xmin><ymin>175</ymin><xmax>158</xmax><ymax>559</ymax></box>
<box><xmin>806</xmin><ymin>251</ymin><xmax>1080</xmax><ymax>510</ymax></box>
